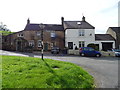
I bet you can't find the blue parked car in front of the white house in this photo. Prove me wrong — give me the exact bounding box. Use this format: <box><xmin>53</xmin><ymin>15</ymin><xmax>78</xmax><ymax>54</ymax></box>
<box><xmin>79</xmin><ymin>47</ymin><xmax>101</xmax><ymax>57</ymax></box>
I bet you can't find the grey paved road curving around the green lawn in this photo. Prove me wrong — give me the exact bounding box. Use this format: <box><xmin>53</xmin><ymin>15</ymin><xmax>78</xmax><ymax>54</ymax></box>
<box><xmin>1</xmin><ymin>51</ymin><xmax>120</xmax><ymax>88</ymax></box>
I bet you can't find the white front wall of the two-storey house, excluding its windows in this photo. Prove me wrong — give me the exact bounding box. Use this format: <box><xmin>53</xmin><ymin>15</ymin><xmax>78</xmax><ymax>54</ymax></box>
<box><xmin>65</xmin><ymin>29</ymin><xmax>95</xmax><ymax>49</ymax></box>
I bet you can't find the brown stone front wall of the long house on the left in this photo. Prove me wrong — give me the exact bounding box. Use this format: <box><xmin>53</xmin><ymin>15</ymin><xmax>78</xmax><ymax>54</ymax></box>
<box><xmin>5</xmin><ymin>30</ymin><xmax>64</xmax><ymax>50</ymax></box>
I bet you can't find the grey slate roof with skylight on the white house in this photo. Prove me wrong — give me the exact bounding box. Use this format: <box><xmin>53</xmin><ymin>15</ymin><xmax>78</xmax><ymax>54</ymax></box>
<box><xmin>64</xmin><ymin>21</ymin><xmax>95</xmax><ymax>29</ymax></box>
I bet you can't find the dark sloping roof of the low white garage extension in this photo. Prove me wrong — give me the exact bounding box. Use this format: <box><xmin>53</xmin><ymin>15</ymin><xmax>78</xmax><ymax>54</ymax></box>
<box><xmin>95</xmin><ymin>34</ymin><xmax>115</xmax><ymax>41</ymax></box>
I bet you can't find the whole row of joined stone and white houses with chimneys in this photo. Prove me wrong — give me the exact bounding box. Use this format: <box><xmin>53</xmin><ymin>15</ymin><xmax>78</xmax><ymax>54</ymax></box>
<box><xmin>2</xmin><ymin>16</ymin><xmax>120</xmax><ymax>51</ymax></box>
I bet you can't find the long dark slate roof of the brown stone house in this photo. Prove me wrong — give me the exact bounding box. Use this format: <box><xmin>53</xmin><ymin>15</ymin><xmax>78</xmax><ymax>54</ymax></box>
<box><xmin>24</xmin><ymin>24</ymin><xmax>64</xmax><ymax>31</ymax></box>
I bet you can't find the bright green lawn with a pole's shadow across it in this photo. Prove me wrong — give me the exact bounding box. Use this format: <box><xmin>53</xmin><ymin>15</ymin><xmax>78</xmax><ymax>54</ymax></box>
<box><xmin>2</xmin><ymin>56</ymin><xmax>94</xmax><ymax>88</ymax></box>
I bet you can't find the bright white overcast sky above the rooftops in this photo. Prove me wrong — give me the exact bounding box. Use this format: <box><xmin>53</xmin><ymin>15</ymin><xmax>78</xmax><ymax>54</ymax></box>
<box><xmin>0</xmin><ymin>0</ymin><xmax>119</xmax><ymax>33</ymax></box>
